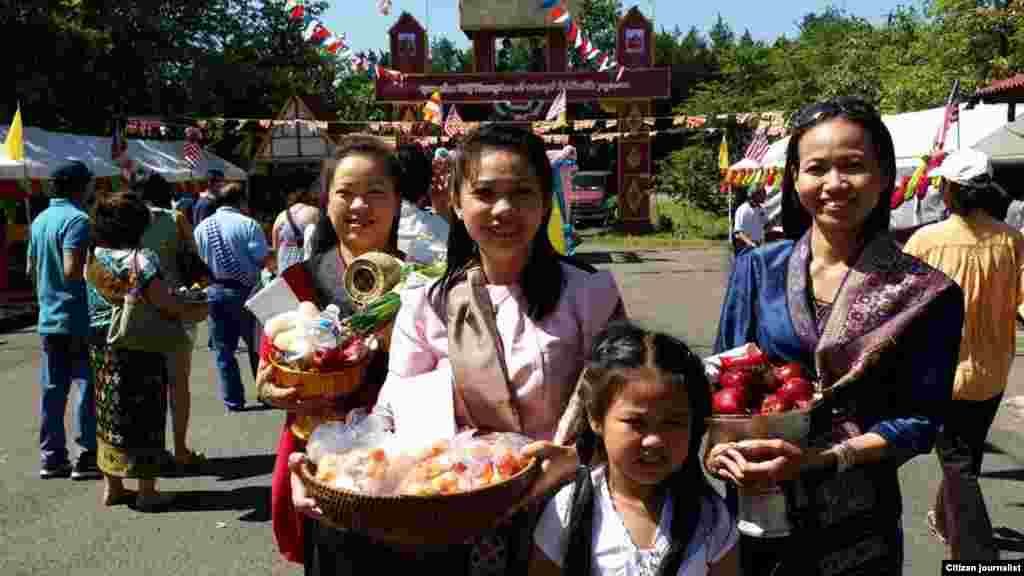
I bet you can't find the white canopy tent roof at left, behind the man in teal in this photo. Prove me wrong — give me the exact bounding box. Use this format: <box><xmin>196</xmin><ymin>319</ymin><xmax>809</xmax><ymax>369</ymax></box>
<box><xmin>0</xmin><ymin>125</ymin><xmax>247</xmax><ymax>182</ymax></box>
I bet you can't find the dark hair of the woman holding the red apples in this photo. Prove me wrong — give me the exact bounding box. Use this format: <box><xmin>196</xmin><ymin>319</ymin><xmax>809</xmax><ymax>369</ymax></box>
<box><xmin>782</xmin><ymin>96</ymin><xmax>896</xmax><ymax>241</ymax></box>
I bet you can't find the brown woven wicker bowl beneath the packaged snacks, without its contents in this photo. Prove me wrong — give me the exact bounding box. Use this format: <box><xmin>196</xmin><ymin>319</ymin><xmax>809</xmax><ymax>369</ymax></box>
<box><xmin>300</xmin><ymin>453</ymin><xmax>541</xmax><ymax>546</ymax></box>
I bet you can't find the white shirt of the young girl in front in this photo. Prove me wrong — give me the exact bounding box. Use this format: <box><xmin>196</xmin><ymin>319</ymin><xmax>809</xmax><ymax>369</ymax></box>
<box><xmin>534</xmin><ymin>465</ymin><xmax>739</xmax><ymax>576</ymax></box>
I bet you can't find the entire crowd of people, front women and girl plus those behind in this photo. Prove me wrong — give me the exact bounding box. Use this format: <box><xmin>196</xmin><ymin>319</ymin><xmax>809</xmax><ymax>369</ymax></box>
<box><xmin>30</xmin><ymin>97</ymin><xmax>1024</xmax><ymax>576</ymax></box>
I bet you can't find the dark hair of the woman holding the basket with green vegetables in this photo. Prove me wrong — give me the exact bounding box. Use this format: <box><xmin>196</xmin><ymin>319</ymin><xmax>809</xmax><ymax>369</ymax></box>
<box><xmin>312</xmin><ymin>136</ymin><xmax>401</xmax><ymax>256</ymax></box>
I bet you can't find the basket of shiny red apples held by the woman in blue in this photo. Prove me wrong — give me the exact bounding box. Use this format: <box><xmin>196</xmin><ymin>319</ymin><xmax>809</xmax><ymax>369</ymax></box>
<box><xmin>705</xmin><ymin>344</ymin><xmax>815</xmax><ymax>444</ymax></box>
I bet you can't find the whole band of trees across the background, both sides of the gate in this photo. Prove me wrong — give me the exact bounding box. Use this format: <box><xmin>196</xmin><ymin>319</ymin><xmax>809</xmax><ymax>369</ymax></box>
<box><xmin>6</xmin><ymin>0</ymin><xmax>1024</xmax><ymax>138</ymax></box>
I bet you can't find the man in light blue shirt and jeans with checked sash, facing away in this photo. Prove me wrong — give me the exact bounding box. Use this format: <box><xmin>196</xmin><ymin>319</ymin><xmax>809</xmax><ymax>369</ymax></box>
<box><xmin>195</xmin><ymin>183</ymin><xmax>269</xmax><ymax>412</ymax></box>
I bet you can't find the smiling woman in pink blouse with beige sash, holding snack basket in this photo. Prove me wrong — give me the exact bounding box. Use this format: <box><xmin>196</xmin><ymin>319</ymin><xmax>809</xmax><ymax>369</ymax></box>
<box><xmin>292</xmin><ymin>126</ymin><xmax>624</xmax><ymax>574</ymax></box>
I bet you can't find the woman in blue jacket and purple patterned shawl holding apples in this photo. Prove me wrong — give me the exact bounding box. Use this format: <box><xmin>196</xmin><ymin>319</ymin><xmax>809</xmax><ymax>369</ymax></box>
<box><xmin>705</xmin><ymin>98</ymin><xmax>964</xmax><ymax>575</ymax></box>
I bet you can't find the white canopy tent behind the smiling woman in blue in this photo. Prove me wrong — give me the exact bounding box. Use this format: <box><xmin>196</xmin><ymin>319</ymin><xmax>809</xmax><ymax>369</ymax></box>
<box><xmin>762</xmin><ymin>105</ymin><xmax>1024</xmax><ymax>230</ymax></box>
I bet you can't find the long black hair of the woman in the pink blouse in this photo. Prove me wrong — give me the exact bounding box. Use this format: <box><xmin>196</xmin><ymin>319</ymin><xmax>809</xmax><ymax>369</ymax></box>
<box><xmin>428</xmin><ymin>124</ymin><xmax>572</xmax><ymax>321</ymax></box>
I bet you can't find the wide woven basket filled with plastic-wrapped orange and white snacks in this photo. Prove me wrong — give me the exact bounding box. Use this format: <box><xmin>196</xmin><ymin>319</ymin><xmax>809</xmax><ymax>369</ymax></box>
<box><xmin>300</xmin><ymin>414</ymin><xmax>540</xmax><ymax>545</ymax></box>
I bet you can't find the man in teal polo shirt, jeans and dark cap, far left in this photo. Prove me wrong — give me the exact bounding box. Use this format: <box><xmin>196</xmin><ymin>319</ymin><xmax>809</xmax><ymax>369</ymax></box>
<box><xmin>28</xmin><ymin>162</ymin><xmax>100</xmax><ymax>480</ymax></box>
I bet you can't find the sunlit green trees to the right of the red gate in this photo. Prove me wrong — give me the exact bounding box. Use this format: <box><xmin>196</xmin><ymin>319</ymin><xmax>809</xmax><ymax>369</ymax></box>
<box><xmin>675</xmin><ymin>0</ymin><xmax>1024</xmax><ymax>114</ymax></box>
